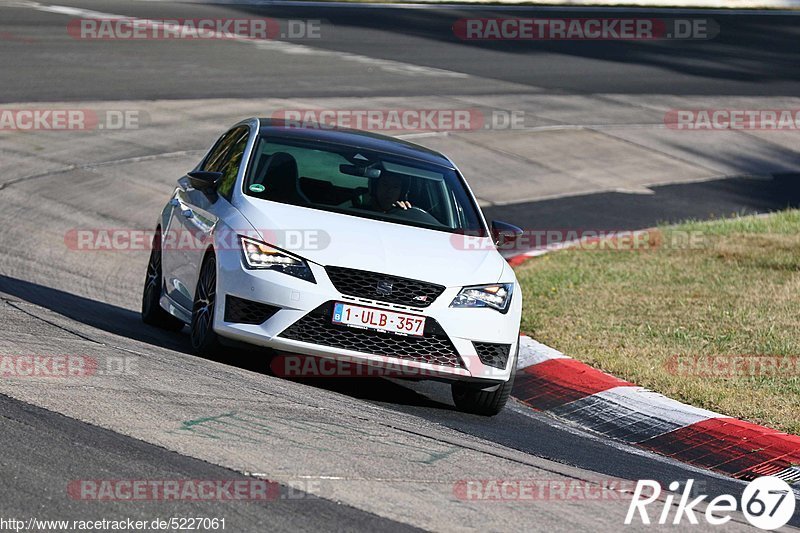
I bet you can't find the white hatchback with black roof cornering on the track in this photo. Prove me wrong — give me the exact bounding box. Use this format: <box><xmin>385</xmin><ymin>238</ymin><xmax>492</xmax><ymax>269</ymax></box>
<box><xmin>142</xmin><ymin>118</ymin><xmax>522</xmax><ymax>415</ymax></box>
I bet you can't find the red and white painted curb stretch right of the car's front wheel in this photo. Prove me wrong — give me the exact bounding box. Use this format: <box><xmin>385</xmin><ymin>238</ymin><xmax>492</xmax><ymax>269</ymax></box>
<box><xmin>513</xmin><ymin>335</ymin><xmax>800</xmax><ymax>484</ymax></box>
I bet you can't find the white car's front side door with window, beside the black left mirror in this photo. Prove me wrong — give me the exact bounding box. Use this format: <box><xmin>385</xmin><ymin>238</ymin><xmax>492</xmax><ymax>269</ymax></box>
<box><xmin>170</xmin><ymin>126</ymin><xmax>250</xmax><ymax>310</ymax></box>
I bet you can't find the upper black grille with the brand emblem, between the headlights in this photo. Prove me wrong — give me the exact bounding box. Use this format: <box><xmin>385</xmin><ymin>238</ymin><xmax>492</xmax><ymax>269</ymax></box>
<box><xmin>325</xmin><ymin>266</ymin><xmax>445</xmax><ymax>307</ymax></box>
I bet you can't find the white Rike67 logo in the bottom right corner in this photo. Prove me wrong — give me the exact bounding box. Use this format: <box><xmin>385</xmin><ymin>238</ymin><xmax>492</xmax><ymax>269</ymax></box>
<box><xmin>625</xmin><ymin>476</ymin><xmax>796</xmax><ymax>530</ymax></box>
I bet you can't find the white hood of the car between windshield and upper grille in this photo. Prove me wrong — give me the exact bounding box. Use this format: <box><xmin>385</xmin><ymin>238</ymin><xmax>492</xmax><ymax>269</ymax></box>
<box><xmin>238</xmin><ymin>197</ymin><xmax>505</xmax><ymax>287</ymax></box>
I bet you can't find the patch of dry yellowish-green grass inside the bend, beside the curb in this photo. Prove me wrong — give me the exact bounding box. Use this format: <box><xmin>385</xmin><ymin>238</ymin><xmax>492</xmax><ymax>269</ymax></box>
<box><xmin>517</xmin><ymin>210</ymin><xmax>800</xmax><ymax>434</ymax></box>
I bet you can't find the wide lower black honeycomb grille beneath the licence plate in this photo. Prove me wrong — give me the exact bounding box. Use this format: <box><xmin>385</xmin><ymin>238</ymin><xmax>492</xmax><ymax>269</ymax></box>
<box><xmin>279</xmin><ymin>302</ymin><xmax>464</xmax><ymax>368</ymax></box>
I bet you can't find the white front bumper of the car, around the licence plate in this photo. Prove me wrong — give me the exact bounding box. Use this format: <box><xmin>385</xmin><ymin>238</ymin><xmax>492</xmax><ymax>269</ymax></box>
<box><xmin>214</xmin><ymin>250</ymin><xmax>522</xmax><ymax>382</ymax></box>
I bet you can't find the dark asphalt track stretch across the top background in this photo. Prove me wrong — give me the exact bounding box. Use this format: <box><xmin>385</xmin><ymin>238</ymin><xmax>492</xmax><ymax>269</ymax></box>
<box><xmin>0</xmin><ymin>0</ymin><xmax>800</xmax><ymax>102</ymax></box>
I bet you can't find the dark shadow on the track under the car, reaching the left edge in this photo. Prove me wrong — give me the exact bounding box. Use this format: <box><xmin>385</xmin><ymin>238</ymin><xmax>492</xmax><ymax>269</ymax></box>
<box><xmin>0</xmin><ymin>274</ymin><xmax>454</xmax><ymax>410</ymax></box>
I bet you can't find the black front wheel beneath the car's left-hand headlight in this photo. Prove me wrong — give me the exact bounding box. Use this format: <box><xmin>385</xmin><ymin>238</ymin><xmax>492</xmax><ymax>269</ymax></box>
<box><xmin>189</xmin><ymin>252</ymin><xmax>222</xmax><ymax>356</ymax></box>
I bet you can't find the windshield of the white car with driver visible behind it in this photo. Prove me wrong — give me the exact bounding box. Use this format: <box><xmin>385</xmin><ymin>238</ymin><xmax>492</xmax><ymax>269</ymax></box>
<box><xmin>244</xmin><ymin>137</ymin><xmax>485</xmax><ymax>235</ymax></box>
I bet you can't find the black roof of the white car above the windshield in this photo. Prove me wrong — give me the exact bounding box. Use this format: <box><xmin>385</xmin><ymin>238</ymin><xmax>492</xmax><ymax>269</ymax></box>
<box><xmin>258</xmin><ymin>118</ymin><xmax>455</xmax><ymax>169</ymax></box>
